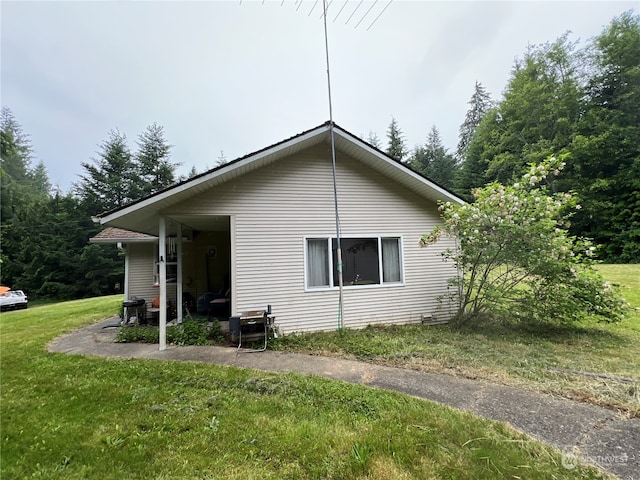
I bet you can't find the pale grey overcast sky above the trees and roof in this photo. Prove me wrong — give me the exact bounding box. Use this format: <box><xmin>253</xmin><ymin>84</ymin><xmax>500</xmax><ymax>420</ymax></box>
<box><xmin>0</xmin><ymin>0</ymin><xmax>639</xmax><ymax>192</ymax></box>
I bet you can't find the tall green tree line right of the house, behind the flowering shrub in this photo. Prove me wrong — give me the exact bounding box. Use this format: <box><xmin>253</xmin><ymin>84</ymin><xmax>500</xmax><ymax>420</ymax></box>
<box><xmin>378</xmin><ymin>11</ymin><xmax>640</xmax><ymax>263</ymax></box>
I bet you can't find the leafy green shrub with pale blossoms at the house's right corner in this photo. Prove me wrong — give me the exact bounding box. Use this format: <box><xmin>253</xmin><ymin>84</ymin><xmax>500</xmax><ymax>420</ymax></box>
<box><xmin>420</xmin><ymin>157</ymin><xmax>625</xmax><ymax>322</ymax></box>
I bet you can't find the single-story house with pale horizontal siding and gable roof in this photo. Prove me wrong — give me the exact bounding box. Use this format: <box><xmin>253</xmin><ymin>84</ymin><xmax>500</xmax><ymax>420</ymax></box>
<box><xmin>94</xmin><ymin>122</ymin><xmax>462</xmax><ymax>349</ymax></box>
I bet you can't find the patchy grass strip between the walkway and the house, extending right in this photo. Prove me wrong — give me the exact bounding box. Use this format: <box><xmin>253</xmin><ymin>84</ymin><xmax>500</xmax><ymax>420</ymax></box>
<box><xmin>277</xmin><ymin>265</ymin><xmax>640</xmax><ymax>416</ymax></box>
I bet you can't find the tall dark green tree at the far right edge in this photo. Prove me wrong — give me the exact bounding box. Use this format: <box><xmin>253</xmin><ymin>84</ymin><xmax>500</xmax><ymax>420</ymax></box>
<box><xmin>565</xmin><ymin>12</ymin><xmax>640</xmax><ymax>262</ymax></box>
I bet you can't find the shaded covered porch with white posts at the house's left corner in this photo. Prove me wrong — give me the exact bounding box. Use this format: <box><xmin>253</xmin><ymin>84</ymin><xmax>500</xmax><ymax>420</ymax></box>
<box><xmin>90</xmin><ymin>215</ymin><xmax>234</xmax><ymax>350</ymax></box>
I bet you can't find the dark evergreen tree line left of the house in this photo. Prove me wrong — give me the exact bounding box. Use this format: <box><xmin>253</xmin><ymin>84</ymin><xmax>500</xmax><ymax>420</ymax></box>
<box><xmin>0</xmin><ymin>113</ymin><xmax>185</xmax><ymax>299</ymax></box>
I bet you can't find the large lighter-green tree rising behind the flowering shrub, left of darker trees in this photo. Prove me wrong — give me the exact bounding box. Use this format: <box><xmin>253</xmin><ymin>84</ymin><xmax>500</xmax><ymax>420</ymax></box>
<box><xmin>458</xmin><ymin>34</ymin><xmax>583</xmax><ymax>194</ymax></box>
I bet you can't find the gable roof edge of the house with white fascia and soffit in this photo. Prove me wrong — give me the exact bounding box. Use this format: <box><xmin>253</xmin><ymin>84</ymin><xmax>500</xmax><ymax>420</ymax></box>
<box><xmin>94</xmin><ymin>122</ymin><xmax>464</xmax><ymax>234</ymax></box>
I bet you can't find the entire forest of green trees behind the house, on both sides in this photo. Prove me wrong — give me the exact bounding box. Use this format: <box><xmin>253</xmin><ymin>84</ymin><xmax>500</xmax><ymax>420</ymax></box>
<box><xmin>0</xmin><ymin>12</ymin><xmax>640</xmax><ymax>299</ymax></box>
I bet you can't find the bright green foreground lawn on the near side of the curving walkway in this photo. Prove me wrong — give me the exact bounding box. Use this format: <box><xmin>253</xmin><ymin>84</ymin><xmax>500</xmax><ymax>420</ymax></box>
<box><xmin>0</xmin><ymin>297</ymin><xmax>604</xmax><ymax>480</ymax></box>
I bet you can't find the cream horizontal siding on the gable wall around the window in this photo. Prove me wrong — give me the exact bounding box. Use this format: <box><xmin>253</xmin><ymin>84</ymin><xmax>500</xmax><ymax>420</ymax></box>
<box><xmin>165</xmin><ymin>147</ymin><xmax>454</xmax><ymax>332</ymax></box>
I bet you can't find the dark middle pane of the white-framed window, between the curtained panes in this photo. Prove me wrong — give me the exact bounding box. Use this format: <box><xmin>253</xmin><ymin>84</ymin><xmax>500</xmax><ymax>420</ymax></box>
<box><xmin>332</xmin><ymin>238</ymin><xmax>380</xmax><ymax>286</ymax></box>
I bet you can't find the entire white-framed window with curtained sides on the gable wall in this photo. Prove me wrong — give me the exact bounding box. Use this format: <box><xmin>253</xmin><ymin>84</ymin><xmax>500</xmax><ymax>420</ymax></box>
<box><xmin>305</xmin><ymin>237</ymin><xmax>403</xmax><ymax>288</ymax></box>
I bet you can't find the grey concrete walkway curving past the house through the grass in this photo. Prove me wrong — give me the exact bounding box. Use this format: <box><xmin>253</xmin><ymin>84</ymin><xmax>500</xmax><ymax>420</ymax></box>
<box><xmin>49</xmin><ymin>319</ymin><xmax>640</xmax><ymax>480</ymax></box>
